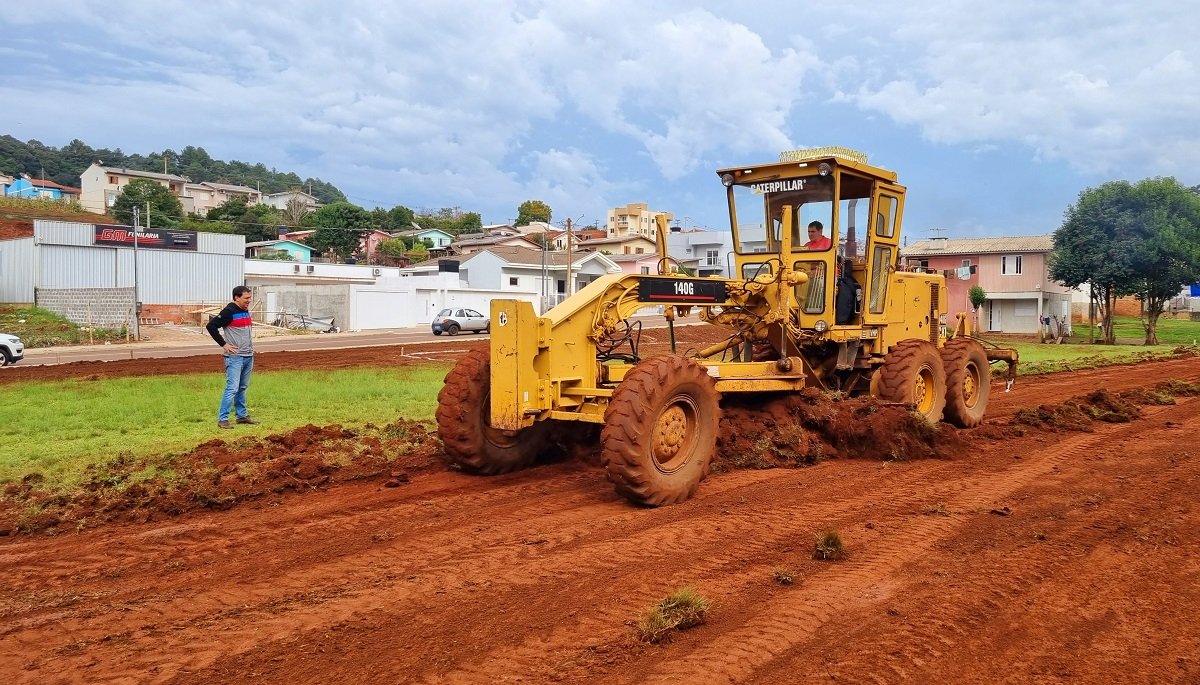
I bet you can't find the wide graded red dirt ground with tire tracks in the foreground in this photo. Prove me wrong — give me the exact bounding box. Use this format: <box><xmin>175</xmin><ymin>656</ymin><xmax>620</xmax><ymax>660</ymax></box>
<box><xmin>0</xmin><ymin>348</ymin><xmax>1200</xmax><ymax>685</ymax></box>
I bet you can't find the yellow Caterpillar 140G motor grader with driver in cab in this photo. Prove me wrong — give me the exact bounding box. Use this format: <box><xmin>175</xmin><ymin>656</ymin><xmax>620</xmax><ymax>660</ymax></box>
<box><xmin>437</xmin><ymin>148</ymin><xmax>1016</xmax><ymax>505</ymax></box>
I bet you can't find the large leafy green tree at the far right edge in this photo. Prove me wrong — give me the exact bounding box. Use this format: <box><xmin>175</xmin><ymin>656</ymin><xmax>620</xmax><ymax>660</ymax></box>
<box><xmin>1050</xmin><ymin>179</ymin><xmax>1200</xmax><ymax>344</ymax></box>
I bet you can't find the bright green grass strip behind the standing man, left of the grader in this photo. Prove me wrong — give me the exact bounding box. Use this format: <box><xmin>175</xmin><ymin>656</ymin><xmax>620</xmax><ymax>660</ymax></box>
<box><xmin>0</xmin><ymin>365</ymin><xmax>448</xmax><ymax>491</ymax></box>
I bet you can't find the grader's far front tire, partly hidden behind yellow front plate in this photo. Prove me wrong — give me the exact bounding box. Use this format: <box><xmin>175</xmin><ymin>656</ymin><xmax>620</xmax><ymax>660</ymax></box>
<box><xmin>437</xmin><ymin>349</ymin><xmax>550</xmax><ymax>475</ymax></box>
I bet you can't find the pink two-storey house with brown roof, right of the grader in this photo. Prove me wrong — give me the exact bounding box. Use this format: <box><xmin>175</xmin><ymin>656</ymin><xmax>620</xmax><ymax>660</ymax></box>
<box><xmin>902</xmin><ymin>235</ymin><xmax>1072</xmax><ymax>334</ymax></box>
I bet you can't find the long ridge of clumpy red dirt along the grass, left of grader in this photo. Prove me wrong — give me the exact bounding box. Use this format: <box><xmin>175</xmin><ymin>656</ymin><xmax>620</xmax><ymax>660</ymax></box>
<box><xmin>0</xmin><ymin>419</ymin><xmax>442</xmax><ymax>535</ymax></box>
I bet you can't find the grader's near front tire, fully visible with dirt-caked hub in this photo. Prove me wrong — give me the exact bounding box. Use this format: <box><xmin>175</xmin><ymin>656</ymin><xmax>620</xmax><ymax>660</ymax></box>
<box><xmin>600</xmin><ymin>356</ymin><xmax>721</xmax><ymax>506</ymax></box>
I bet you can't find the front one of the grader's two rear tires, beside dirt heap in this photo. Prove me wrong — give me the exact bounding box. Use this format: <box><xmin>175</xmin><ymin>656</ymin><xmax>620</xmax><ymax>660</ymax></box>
<box><xmin>875</xmin><ymin>341</ymin><xmax>946</xmax><ymax>423</ymax></box>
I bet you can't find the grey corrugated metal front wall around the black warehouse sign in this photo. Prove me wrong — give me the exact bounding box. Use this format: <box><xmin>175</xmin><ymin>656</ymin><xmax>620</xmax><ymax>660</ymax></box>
<box><xmin>26</xmin><ymin>221</ymin><xmax>246</xmax><ymax>305</ymax></box>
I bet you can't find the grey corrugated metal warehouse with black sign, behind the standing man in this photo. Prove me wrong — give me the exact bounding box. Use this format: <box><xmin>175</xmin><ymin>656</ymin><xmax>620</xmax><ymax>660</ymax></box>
<box><xmin>0</xmin><ymin>220</ymin><xmax>246</xmax><ymax>328</ymax></box>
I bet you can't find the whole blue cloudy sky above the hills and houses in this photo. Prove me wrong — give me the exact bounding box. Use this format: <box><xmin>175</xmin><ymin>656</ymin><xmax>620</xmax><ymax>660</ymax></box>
<box><xmin>0</xmin><ymin>0</ymin><xmax>1200</xmax><ymax>240</ymax></box>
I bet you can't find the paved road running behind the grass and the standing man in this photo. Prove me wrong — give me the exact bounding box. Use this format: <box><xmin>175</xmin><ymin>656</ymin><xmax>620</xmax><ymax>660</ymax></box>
<box><xmin>19</xmin><ymin>316</ymin><xmax>697</xmax><ymax>366</ymax></box>
